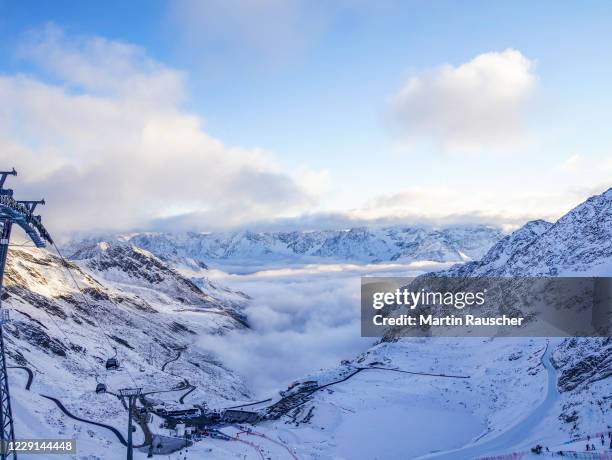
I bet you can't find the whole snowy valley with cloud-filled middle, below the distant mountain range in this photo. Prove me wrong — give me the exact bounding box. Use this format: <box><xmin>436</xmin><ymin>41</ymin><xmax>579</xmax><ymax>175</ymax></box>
<box><xmin>3</xmin><ymin>191</ymin><xmax>612</xmax><ymax>460</ymax></box>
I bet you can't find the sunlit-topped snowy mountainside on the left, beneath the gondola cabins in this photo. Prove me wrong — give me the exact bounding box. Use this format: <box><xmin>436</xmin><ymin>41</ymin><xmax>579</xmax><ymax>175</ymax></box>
<box><xmin>3</xmin><ymin>244</ymin><xmax>249</xmax><ymax>459</ymax></box>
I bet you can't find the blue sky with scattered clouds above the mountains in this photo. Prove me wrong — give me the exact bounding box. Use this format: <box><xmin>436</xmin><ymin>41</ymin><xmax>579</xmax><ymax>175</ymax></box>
<box><xmin>0</xmin><ymin>0</ymin><xmax>612</xmax><ymax>234</ymax></box>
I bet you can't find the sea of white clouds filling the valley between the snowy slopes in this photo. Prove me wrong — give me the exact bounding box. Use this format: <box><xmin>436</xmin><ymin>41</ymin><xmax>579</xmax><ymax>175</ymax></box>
<box><xmin>200</xmin><ymin>263</ymin><xmax>443</xmax><ymax>397</ymax></box>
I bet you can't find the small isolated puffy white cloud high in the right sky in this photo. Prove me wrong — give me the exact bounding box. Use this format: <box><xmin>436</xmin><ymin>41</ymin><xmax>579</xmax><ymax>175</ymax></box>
<box><xmin>392</xmin><ymin>49</ymin><xmax>536</xmax><ymax>150</ymax></box>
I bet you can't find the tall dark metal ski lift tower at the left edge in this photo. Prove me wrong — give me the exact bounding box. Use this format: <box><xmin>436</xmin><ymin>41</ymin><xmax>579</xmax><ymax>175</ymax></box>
<box><xmin>0</xmin><ymin>168</ymin><xmax>53</xmax><ymax>460</ymax></box>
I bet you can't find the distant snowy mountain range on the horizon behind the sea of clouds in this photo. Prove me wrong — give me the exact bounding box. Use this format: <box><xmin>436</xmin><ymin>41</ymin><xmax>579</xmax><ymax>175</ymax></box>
<box><xmin>70</xmin><ymin>225</ymin><xmax>503</xmax><ymax>269</ymax></box>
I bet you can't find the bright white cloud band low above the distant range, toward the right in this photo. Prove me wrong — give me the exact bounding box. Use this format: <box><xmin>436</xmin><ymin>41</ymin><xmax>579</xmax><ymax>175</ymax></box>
<box><xmin>155</xmin><ymin>181</ymin><xmax>610</xmax><ymax>235</ymax></box>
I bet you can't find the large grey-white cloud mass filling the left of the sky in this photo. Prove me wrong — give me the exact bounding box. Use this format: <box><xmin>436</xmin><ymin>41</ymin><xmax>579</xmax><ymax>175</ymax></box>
<box><xmin>0</xmin><ymin>26</ymin><xmax>326</xmax><ymax>233</ymax></box>
